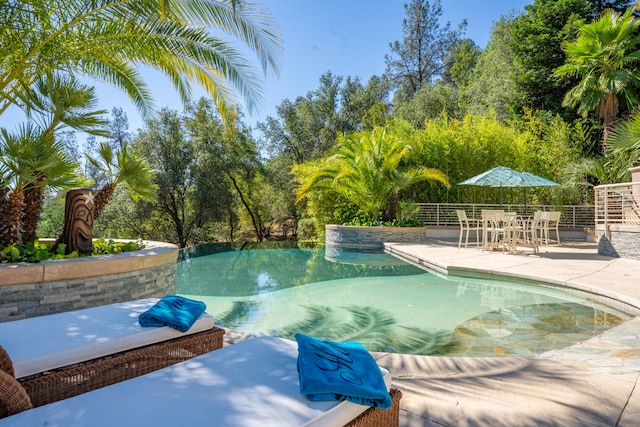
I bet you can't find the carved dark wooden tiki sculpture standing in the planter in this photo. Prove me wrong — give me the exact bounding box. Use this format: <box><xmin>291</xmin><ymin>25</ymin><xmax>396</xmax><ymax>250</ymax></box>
<box><xmin>62</xmin><ymin>188</ymin><xmax>93</xmax><ymax>255</ymax></box>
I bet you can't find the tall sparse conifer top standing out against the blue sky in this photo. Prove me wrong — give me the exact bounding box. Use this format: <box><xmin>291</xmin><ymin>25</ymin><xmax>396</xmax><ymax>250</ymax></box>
<box><xmin>385</xmin><ymin>0</ymin><xmax>467</xmax><ymax>103</ymax></box>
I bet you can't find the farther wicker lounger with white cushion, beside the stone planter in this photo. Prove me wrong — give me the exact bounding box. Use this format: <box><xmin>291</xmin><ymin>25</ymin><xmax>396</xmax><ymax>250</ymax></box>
<box><xmin>0</xmin><ymin>299</ymin><xmax>224</xmax><ymax>407</ymax></box>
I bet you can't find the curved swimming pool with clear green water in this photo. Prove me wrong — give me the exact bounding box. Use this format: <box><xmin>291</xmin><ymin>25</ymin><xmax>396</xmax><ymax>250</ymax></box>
<box><xmin>177</xmin><ymin>245</ymin><xmax>633</xmax><ymax>356</ymax></box>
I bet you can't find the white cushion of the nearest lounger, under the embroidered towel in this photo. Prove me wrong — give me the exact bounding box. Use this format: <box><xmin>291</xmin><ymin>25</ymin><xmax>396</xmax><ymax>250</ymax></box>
<box><xmin>0</xmin><ymin>337</ymin><xmax>391</xmax><ymax>427</ymax></box>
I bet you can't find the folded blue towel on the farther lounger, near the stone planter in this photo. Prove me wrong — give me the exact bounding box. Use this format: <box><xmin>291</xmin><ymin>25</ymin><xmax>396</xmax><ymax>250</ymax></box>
<box><xmin>138</xmin><ymin>294</ymin><xmax>207</xmax><ymax>332</ymax></box>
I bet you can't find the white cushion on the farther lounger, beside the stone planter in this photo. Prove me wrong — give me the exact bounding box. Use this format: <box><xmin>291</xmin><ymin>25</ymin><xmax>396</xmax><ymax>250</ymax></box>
<box><xmin>0</xmin><ymin>298</ymin><xmax>214</xmax><ymax>378</ymax></box>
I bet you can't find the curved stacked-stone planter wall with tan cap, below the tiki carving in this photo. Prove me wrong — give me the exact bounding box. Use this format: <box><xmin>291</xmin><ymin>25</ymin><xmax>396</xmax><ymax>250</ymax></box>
<box><xmin>0</xmin><ymin>242</ymin><xmax>178</xmax><ymax>322</ymax></box>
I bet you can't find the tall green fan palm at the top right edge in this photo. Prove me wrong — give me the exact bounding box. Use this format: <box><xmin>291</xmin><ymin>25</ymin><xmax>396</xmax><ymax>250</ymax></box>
<box><xmin>555</xmin><ymin>8</ymin><xmax>640</xmax><ymax>153</ymax></box>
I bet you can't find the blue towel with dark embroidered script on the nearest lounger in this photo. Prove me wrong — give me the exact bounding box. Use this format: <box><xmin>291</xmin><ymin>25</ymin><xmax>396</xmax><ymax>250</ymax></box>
<box><xmin>296</xmin><ymin>334</ymin><xmax>392</xmax><ymax>409</ymax></box>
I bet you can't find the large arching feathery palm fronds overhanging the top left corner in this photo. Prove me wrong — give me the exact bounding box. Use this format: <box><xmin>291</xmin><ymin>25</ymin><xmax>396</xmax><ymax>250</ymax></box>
<box><xmin>0</xmin><ymin>0</ymin><xmax>281</xmax><ymax>117</ymax></box>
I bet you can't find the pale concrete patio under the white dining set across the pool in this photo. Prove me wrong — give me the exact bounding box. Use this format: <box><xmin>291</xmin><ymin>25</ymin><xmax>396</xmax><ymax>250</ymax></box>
<box><xmin>385</xmin><ymin>241</ymin><xmax>640</xmax><ymax>315</ymax></box>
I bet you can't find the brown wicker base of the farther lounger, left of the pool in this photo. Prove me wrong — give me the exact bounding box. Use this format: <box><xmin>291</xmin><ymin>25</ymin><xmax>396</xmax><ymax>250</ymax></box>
<box><xmin>18</xmin><ymin>326</ymin><xmax>225</xmax><ymax>407</ymax></box>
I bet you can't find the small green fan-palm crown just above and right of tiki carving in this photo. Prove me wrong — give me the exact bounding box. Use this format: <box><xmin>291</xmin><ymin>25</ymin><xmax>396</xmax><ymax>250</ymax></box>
<box><xmin>87</xmin><ymin>143</ymin><xmax>158</xmax><ymax>221</ymax></box>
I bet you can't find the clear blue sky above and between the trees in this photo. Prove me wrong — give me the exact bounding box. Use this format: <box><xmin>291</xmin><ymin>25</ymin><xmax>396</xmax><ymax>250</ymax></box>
<box><xmin>0</xmin><ymin>0</ymin><xmax>533</xmax><ymax>142</ymax></box>
